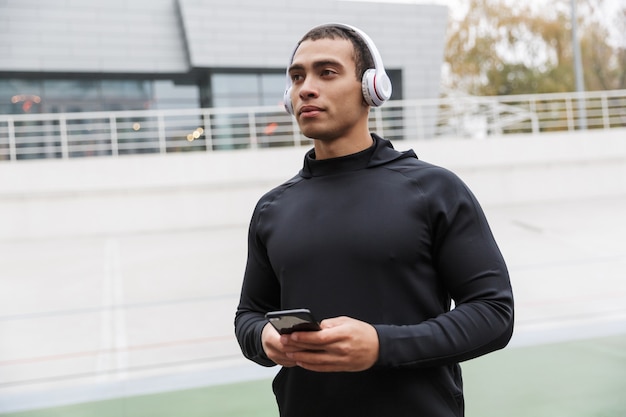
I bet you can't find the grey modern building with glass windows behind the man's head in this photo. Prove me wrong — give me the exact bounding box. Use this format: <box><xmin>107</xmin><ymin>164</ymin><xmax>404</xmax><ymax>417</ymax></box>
<box><xmin>0</xmin><ymin>0</ymin><xmax>447</xmax><ymax>115</ymax></box>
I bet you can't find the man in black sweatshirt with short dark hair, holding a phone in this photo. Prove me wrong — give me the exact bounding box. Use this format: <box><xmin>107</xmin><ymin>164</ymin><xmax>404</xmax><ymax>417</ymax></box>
<box><xmin>235</xmin><ymin>24</ymin><xmax>513</xmax><ymax>417</ymax></box>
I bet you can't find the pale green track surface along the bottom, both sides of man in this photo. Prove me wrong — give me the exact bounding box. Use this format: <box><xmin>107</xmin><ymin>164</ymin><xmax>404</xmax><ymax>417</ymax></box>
<box><xmin>0</xmin><ymin>334</ymin><xmax>626</xmax><ymax>417</ymax></box>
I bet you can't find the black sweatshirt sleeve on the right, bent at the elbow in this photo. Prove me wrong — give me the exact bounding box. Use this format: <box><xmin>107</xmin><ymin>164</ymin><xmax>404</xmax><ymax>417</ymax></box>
<box><xmin>375</xmin><ymin>169</ymin><xmax>513</xmax><ymax>367</ymax></box>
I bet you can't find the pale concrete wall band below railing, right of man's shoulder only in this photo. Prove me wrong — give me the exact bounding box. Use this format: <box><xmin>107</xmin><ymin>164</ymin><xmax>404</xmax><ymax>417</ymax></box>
<box><xmin>416</xmin><ymin>129</ymin><xmax>626</xmax><ymax>206</ymax></box>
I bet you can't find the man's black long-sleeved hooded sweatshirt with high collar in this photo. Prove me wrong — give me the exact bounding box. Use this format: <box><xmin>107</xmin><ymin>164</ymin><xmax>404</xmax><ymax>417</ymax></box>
<box><xmin>235</xmin><ymin>135</ymin><xmax>513</xmax><ymax>417</ymax></box>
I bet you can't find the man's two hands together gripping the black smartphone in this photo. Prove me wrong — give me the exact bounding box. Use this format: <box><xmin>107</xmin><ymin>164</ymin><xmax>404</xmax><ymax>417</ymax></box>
<box><xmin>263</xmin><ymin>317</ymin><xmax>379</xmax><ymax>372</ymax></box>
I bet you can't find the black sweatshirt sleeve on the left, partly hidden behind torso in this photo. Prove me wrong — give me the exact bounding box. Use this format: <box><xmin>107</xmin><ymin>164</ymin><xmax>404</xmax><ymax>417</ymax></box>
<box><xmin>235</xmin><ymin>200</ymin><xmax>280</xmax><ymax>366</ymax></box>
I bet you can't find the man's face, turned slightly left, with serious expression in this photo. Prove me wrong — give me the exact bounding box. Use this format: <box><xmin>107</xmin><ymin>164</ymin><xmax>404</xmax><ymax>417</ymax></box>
<box><xmin>289</xmin><ymin>39</ymin><xmax>369</xmax><ymax>141</ymax></box>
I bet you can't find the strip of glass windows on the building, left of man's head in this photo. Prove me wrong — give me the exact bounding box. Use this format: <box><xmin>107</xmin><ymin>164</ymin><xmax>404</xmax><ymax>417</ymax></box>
<box><xmin>0</xmin><ymin>70</ymin><xmax>292</xmax><ymax>114</ymax></box>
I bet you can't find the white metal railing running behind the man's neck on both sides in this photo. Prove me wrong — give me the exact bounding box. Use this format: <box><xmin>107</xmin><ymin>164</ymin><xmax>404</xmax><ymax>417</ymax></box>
<box><xmin>0</xmin><ymin>90</ymin><xmax>626</xmax><ymax>161</ymax></box>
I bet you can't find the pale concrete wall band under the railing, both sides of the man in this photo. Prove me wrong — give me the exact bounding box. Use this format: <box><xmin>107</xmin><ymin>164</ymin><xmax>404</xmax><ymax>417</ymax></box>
<box><xmin>0</xmin><ymin>129</ymin><xmax>626</xmax><ymax>240</ymax></box>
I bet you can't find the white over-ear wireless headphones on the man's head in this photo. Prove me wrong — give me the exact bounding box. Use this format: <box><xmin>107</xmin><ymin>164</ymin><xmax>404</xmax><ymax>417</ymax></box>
<box><xmin>283</xmin><ymin>23</ymin><xmax>391</xmax><ymax>114</ymax></box>
